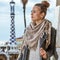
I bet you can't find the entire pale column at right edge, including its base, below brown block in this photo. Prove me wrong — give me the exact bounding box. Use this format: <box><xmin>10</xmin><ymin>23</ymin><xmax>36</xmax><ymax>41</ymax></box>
<box><xmin>55</xmin><ymin>6</ymin><xmax>60</xmax><ymax>60</ymax></box>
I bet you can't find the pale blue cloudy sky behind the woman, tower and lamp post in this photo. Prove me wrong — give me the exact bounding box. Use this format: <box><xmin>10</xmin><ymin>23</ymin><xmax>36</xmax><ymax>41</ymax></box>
<box><xmin>0</xmin><ymin>0</ymin><xmax>57</xmax><ymax>41</ymax></box>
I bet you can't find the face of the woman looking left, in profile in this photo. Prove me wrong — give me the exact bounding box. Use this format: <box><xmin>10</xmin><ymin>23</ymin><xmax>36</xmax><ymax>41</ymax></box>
<box><xmin>31</xmin><ymin>6</ymin><xmax>42</xmax><ymax>22</ymax></box>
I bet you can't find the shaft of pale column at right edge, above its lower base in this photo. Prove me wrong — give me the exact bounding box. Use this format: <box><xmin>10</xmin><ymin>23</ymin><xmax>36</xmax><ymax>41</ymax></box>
<box><xmin>55</xmin><ymin>6</ymin><xmax>60</xmax><ymax>48</ymax></box>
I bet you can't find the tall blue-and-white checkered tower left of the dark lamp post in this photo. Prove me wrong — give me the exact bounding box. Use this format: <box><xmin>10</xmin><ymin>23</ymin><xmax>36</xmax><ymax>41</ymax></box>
<box><xmin>10</xmin><ymin>0</ymin><xmax>16</xmax><ymax>44</ymax></box>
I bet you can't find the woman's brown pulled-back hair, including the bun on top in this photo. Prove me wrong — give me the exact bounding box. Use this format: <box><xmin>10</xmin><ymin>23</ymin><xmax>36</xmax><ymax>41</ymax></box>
<box><xmin>35</xmin><ymin>1</ymin><xmax>50</xmax><ymax>17</ymax></box>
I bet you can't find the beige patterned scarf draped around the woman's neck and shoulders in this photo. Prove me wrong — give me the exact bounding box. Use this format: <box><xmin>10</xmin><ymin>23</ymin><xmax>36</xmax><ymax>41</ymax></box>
<box><xmin>23</xmin><ymin>19</ymin><xmax>51</xmax><ymax>49</ymax></box>
